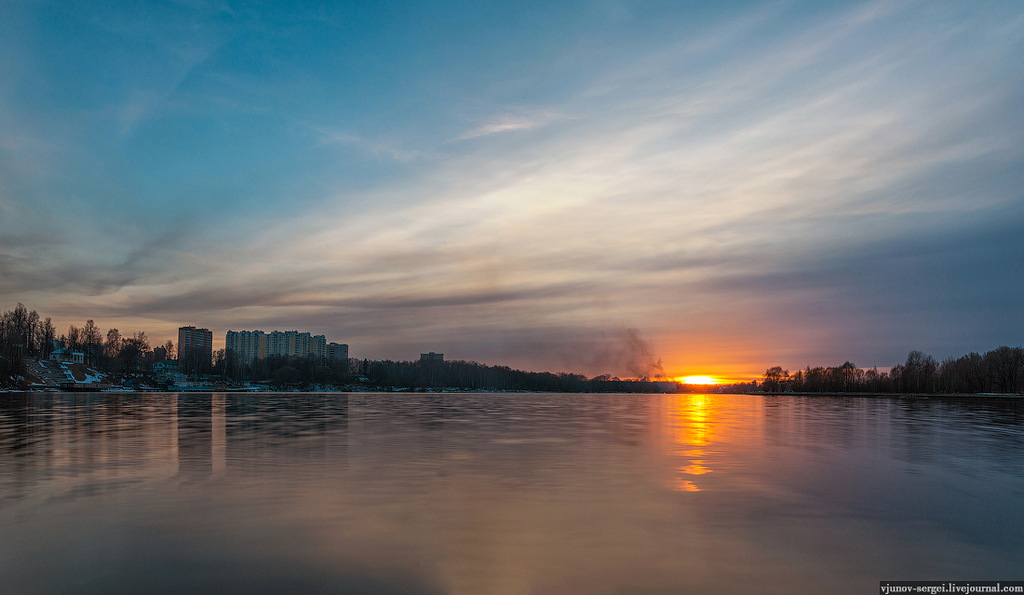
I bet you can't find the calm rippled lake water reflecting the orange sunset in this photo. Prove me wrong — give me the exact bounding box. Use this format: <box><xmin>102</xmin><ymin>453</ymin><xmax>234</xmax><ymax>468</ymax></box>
<box><xmin>0</xmin><ymin>393</ymin><xmax>1024</xmax><ymax>594</ymax></box>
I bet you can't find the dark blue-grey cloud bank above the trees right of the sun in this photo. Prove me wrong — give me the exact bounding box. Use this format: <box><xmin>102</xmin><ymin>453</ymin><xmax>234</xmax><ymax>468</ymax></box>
<box><xmin>685</xmin><ymin>199</ymin><xmax>1024</xmax><ymax>368</ymax></box>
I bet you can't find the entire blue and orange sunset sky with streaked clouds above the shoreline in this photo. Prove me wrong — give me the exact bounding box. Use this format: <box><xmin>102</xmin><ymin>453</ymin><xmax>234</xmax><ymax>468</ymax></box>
<box><xmin>0</xmin><ymin>0</ymin><xmax>1024</xmax><ymax>380</ymax></box>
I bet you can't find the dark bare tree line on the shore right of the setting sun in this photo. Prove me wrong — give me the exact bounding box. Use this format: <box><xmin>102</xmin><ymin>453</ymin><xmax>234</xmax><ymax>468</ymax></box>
<box><xmin>762</xmin><ymin>345</ymin><xmax>1024</xmax><ymax>394</ymax></box>
